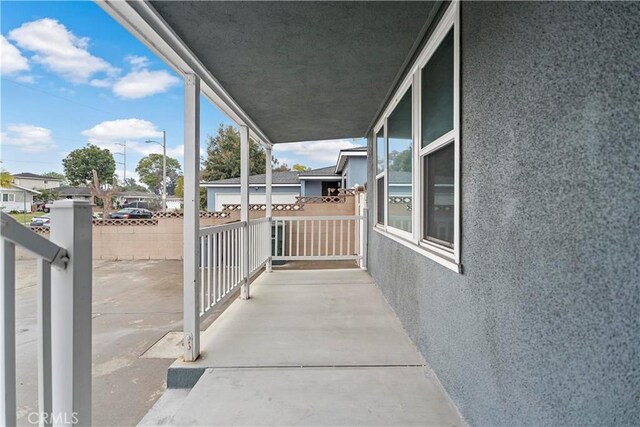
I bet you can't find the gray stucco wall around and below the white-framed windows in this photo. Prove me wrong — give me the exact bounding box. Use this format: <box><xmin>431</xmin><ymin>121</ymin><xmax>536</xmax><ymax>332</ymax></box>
<box><xmin>368</xmin><ymin>2</ymin><xmax>640</xmax><ymax>426</ymax></box>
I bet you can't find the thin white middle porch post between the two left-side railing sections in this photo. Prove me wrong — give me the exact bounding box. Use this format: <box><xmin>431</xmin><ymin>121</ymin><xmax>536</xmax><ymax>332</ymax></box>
<box><xmin>240</xmin><ymin>126</ymin><xmax>250</xmax><ymax>299</ymax></box>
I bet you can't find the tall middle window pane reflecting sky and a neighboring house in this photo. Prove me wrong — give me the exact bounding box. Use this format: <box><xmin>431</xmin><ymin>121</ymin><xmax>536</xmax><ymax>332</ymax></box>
<box><xmin>387</xmin><ymin>87</ymin><xmax>413</xmax><ymax>233</ymax></box>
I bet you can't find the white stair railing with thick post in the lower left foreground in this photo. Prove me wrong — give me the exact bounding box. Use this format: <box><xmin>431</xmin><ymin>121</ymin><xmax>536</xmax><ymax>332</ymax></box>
<box><xmin>0</xmin><ymin>200</ymin><xmax>92</xmax><ymax>426</ymax></box>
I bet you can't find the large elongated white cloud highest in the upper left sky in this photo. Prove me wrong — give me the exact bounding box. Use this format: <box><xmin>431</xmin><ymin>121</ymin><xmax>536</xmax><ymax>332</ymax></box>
<box><xmin>9</xmin><ymin>18</ymin><xmax>120</xmax><ymax>84</ymax></box>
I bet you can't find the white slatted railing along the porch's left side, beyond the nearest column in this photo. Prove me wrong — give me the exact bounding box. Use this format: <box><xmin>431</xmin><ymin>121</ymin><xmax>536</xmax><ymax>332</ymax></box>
<box><xmin>200</xmin><ymin>218</ymin><xmax>271</xmax><ymax>317</ymax></box>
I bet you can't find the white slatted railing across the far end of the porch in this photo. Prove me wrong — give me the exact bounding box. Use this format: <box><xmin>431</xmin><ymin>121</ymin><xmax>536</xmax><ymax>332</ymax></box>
<box><xmin>272</xmin><ymin>215</ymin><xmax>365</xmax><ymax>261</ymax></box>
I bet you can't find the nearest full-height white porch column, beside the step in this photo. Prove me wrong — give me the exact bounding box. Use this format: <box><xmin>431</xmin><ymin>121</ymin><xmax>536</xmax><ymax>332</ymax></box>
<box><xmin>182</xmin><ymin>74</ymin><xmax>200</xmax><ymax>362</ymax></box>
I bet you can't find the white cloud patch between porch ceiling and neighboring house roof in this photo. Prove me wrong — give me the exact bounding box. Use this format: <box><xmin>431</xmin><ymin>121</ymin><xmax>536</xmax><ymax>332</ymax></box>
<box><xmin>273</xmin><ymin>139</ymin><xmax>358</xmax><ymax>166</ymax></box>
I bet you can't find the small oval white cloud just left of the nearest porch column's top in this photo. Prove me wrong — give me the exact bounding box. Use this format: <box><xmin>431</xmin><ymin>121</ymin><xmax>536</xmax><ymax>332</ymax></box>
<box><xmin>113</xmin><ymin>70</ymin><xmax>180</xmax><ymax>99</ymax></box>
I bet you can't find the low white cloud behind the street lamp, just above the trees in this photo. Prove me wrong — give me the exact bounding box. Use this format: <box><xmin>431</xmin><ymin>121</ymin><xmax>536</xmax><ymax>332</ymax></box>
<box><xmin>82</xmin><ymin>119</ymin><xmax>184</xmax><ymax>157</ymax></box>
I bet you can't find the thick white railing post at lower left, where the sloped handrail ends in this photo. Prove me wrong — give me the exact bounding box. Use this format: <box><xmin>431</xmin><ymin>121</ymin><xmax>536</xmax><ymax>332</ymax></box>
<box><xmin>50</xmin><ymin>200</ymin><xmax>92</xmax><ymax>426</ymax></box>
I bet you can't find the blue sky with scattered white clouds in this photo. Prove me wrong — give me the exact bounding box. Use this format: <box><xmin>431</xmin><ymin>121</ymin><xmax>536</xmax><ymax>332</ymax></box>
<box><xmin>0</xmin><ymin>1</ymin><xmax>364</xmax><ymax>186</ymax></box>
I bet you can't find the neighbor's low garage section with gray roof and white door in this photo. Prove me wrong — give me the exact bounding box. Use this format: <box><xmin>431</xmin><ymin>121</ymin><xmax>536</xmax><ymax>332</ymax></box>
<box><xmin>200</xmin><ymin>171</ymin><xmax>301</xmax><ymax>211</ymax></box>
